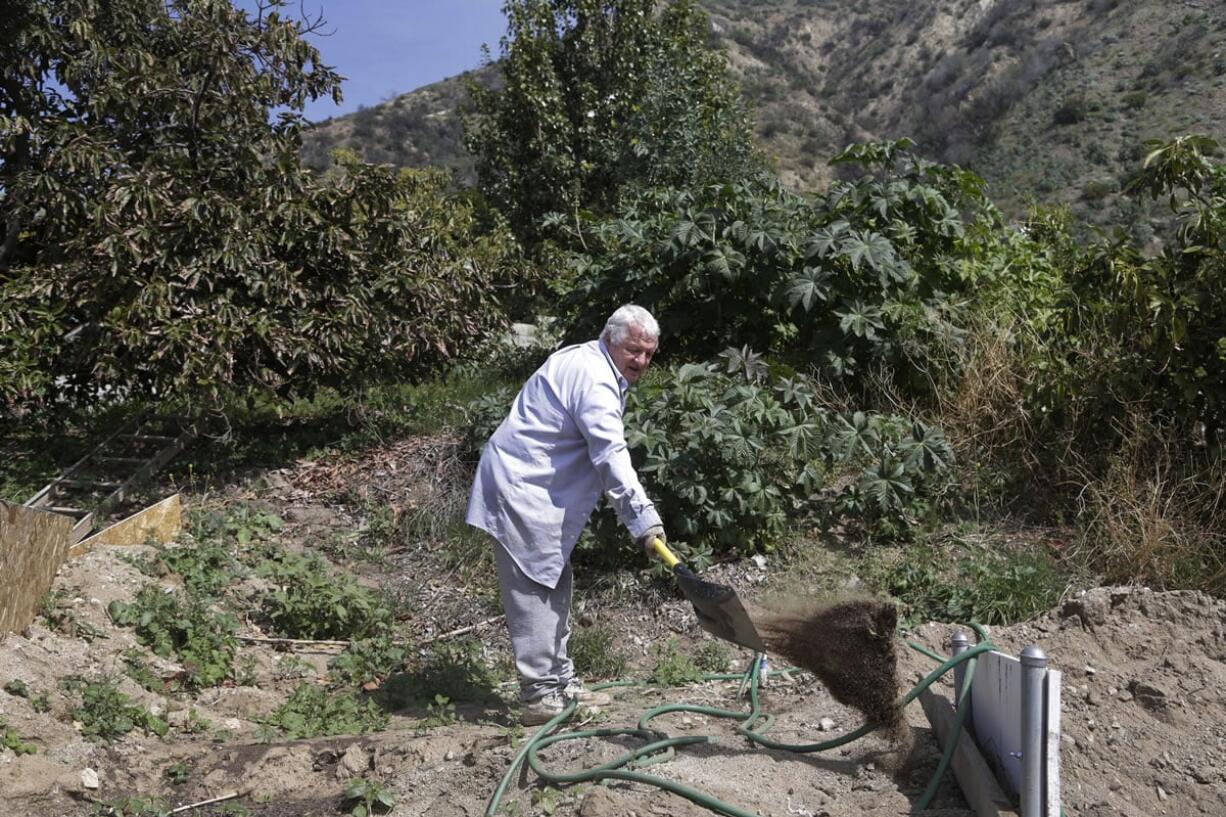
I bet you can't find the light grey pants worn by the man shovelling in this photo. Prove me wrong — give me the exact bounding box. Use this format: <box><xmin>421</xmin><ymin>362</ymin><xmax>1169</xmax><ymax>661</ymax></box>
<box><xmin>494</xmin><ymin>541</ymin><xmax>575</xmax><ymax>703</ymax></box>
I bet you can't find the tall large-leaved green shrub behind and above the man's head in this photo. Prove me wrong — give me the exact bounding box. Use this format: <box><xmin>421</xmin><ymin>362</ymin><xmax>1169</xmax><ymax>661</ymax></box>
<box><xmin>554</xmin><ymin>140</ymin><xmax>998</xmax><ymax>391</ymax></box>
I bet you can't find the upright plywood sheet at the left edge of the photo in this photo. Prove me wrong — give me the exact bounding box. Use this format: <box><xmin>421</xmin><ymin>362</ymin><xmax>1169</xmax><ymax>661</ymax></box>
<box><xmin>0</xmin><ymin>501</ymin><xmax>72</xmax><ymax>634</ymax></box>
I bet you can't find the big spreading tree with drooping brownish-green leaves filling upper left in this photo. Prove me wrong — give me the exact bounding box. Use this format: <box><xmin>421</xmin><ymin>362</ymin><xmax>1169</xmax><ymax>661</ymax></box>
<box><xmin>0</xmin><ymin>0</ymin><xmax>510</xmax><ymax>413</ymax></box>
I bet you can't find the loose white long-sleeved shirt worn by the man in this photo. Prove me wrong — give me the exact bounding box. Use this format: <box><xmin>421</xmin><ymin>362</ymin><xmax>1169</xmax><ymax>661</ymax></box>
<box><xmin>465</xmin><ymin>340</ymin><xmax>660</xmax><ymax>588</ymax></box>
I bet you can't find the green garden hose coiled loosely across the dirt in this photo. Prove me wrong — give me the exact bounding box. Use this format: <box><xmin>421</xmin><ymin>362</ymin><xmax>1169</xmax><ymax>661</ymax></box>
<box><xmin>485</xmin><ymin>624</ymin><xmax>1010</xmax><ymax>817</ymax></box>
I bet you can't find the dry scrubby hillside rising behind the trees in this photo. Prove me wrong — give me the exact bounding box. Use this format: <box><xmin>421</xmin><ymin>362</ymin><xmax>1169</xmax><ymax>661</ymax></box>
<box><xmin>305</xmin><ymin>0</ymin><xmax>1226</xmax><ymax>221</ymax></box>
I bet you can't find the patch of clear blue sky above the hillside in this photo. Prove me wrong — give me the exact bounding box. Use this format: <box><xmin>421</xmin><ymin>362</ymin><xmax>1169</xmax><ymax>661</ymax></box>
<box><xmin>235</xmin><ymin>0</ymin><xmax>506</xmax><ymax>121</ymax></box>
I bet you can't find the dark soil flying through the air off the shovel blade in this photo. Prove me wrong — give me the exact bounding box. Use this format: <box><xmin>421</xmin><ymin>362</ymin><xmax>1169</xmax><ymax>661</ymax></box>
<box><xmin>753</xmin><ymin>599</ymin><xmax>902</xmax><ymax>735</ymax></box>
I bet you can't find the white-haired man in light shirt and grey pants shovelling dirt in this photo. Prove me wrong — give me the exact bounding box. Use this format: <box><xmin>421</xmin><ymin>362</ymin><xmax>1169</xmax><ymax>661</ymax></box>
<box><xmin>466</xmin><ymin>304</ymin><xmax>664</xmax><ymax>725</ymax></box>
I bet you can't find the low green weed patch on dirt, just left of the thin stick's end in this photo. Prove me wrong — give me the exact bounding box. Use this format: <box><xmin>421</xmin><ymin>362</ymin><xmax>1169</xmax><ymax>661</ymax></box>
<box><xmin>107</xmin><ymin>584</ymin><xmax>238</xmax><ymax>687</ymax></box>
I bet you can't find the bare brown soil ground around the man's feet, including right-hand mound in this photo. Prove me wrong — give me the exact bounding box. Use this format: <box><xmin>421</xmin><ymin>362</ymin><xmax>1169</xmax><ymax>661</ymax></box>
<box><xmin>0</xmin><ymin>440</ymin><xmax>1226</xmax><ymax>817</ymax></box>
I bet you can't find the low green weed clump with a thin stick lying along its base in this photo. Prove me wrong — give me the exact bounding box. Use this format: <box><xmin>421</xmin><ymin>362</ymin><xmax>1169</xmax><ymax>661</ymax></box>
<box><xmin>256</xmin><ymin>551</ymin><xmax>391</xmax><ymax>639</ymax></box>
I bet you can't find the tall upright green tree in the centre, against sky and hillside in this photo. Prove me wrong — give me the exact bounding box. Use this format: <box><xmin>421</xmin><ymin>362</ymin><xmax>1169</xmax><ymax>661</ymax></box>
<box><xmin>465</xmin><ymin>0</ymin><xmax>760</xmax><ymax>239</ymax></box>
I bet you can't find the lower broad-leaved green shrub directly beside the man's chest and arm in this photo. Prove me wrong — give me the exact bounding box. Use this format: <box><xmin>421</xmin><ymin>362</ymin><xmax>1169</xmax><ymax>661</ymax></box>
<box><xmin>578</xmin><ymin>350</ymin><xmax>953</xmax><ymax>554</ymax></box>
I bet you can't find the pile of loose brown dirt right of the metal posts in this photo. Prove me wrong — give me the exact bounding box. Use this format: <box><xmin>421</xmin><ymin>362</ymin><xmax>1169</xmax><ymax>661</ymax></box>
<box><xmin>906</xmin><ymin>588</ymin><xmax>1226</xmax><ymax>817</ymax></box>
